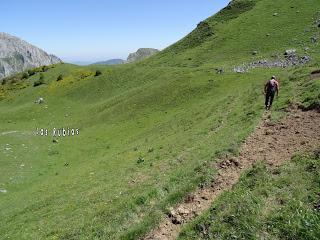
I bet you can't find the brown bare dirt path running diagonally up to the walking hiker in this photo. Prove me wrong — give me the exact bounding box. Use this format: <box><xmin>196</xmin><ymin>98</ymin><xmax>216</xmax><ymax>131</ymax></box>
<box><xmin>143</xmin><ymin>109</ymin><xmax>320</xmax><ymax>240</ymax></box>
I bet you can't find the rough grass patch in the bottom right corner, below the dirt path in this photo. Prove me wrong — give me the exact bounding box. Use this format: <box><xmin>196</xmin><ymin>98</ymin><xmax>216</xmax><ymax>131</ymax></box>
<box><xmin>179</xmin><ymin>151</ymin><xmax>320</xmax><ymax>240</ymax></box>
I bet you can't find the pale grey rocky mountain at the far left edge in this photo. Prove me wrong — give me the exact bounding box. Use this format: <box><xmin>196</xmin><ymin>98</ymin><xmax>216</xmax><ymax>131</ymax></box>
<box><xmin>0</xmin><ymin>32</ymin><xmax>61</xmax><ymax>79</ymax></box>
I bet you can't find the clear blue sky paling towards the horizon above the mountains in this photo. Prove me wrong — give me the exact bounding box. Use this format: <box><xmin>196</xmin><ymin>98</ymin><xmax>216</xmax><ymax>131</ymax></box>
<box><xmin>0</xmin><ymin>0</ymin><xmax>229</xmax><ymax>62</ymax></box>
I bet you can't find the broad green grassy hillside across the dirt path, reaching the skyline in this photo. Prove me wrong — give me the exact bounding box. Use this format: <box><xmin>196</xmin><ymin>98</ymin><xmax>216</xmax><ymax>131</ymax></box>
<box><xmin>0</xmin><ymin>0</ymin><xmax>320</xmax><ymax>239</ymax></box>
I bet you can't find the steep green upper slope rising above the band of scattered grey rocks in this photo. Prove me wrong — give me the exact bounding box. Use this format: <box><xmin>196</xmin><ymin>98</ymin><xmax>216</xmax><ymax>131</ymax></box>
<box><xmin>146</xmin><ymin>0</ymin><xmax>319</xmax><ymax>67</ymax></box>
